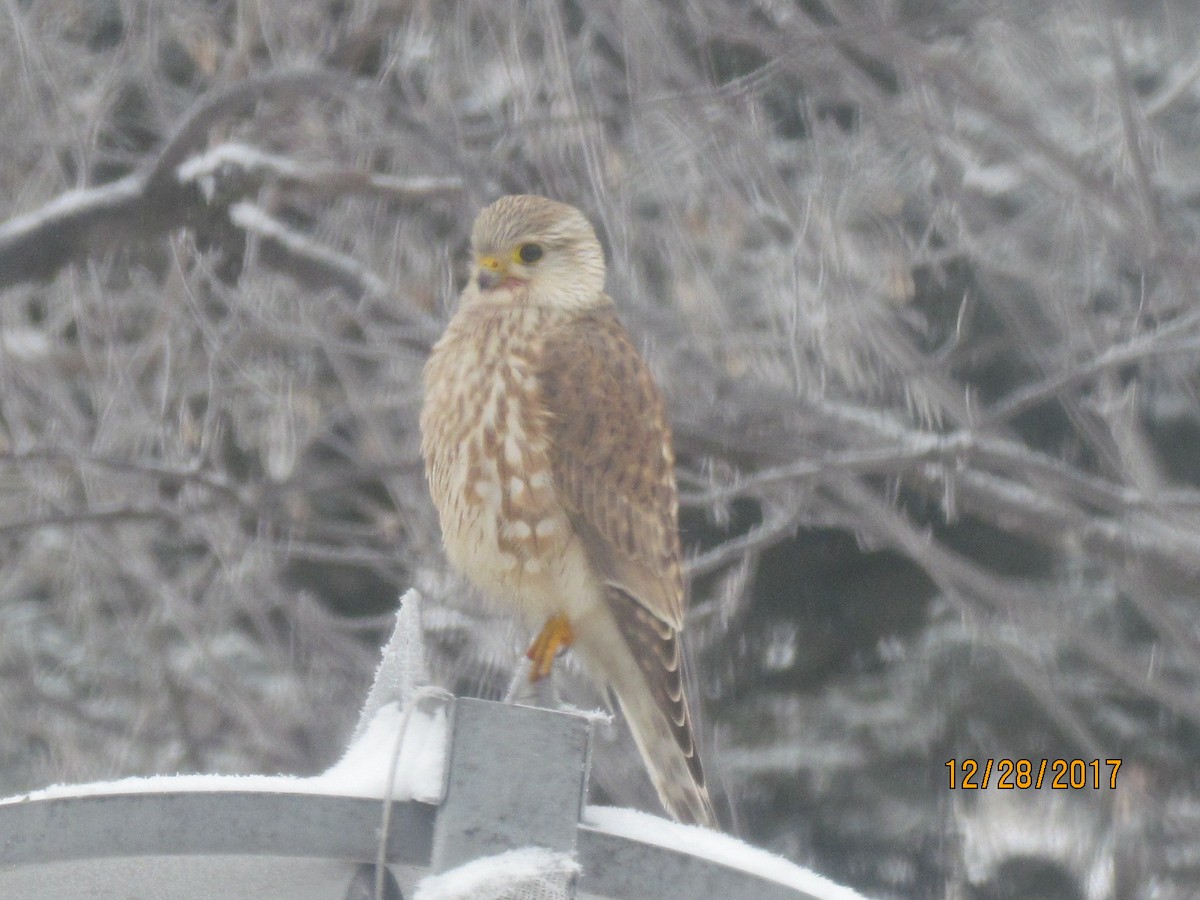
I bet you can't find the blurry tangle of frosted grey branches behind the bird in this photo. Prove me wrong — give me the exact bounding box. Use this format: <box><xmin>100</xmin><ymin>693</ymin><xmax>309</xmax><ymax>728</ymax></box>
<box><xmin>0</xmin><ymin>0</ymin><xmax>1200</xmax><ymax>899</ymax></box>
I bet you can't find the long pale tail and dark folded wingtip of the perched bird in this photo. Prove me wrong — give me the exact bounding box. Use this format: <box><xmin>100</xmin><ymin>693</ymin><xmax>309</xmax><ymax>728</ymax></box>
<box><xmin>576</xmin><ymin>587</ymin><xmax>716</xmax><ymax>828</ymax></box>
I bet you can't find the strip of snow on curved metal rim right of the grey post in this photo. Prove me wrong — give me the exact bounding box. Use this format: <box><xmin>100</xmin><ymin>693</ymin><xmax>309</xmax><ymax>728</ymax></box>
<box><xmin>583</xmin><ymin>806</ymin><xmax>865</xmax><ymax>900</ymax></box>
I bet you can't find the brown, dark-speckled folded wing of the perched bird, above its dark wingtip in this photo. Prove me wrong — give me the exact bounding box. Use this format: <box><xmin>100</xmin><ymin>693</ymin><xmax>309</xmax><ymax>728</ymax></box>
<box><xmin>539</xmin><ymin>308</ymin><xmax>683</xmax><ymax>630</ymax></box>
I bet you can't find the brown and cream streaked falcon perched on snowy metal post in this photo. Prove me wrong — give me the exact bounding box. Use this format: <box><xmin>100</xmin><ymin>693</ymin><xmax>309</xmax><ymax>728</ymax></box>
<box><xmin>420</xmin><ymin>194</ymin><xmax>716</xmax><ymax>828</ymax></box>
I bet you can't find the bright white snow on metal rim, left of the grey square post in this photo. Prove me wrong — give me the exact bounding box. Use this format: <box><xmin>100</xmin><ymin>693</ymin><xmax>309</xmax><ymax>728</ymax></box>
<box><xmin>0</xmin><ymin>702</ymin><xmax>449</xmax><ymax>804</ymax></box>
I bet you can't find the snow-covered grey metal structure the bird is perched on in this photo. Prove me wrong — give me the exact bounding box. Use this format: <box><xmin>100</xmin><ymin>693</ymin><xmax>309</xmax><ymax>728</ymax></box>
<box><xmin>0</xmin><ymin>604</ymin><xmax>862</xmax><ymax>900</ymax></box>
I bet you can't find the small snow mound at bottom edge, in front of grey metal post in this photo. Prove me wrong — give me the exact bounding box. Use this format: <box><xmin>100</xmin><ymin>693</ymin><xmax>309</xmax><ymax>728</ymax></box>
<box><xmin>413</xmin><ymin>847</ymin><xmax>580</xmax><ymax>900</ymax></box>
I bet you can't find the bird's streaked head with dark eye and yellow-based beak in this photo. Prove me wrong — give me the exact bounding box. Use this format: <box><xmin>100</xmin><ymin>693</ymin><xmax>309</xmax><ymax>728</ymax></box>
<box><xmin>470</xmin><ymin>194</ymin><xmax>605</xmax><ymax>308</ymax></box>
